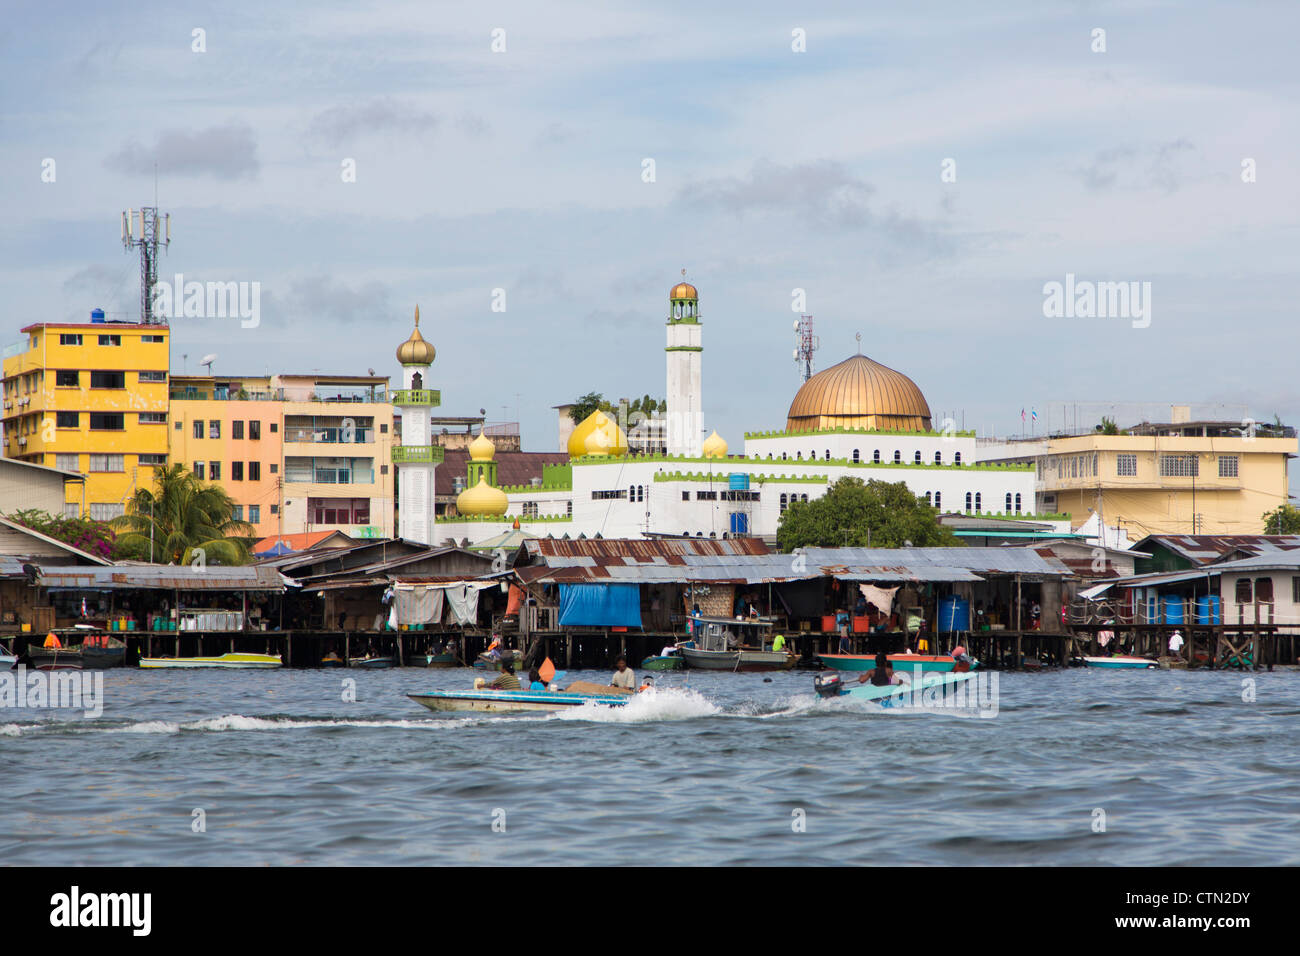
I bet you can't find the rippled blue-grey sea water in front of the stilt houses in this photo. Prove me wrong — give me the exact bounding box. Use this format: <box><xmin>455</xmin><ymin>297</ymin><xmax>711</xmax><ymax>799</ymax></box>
<box><xmin>0</xmin><ymin>669</ymin><xmax>1300</xmax><ymax>865</ymax></box>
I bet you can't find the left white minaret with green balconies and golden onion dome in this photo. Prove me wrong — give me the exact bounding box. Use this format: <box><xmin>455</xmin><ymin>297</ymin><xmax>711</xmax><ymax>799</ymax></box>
<box><xmin>393</xmin><ymin>306</ymin><xmax>442</xmax><ymax>545</ymax></box>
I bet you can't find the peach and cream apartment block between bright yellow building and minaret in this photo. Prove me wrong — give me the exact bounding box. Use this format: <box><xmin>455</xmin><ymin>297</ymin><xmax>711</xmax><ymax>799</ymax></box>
<box><xmin>169</xmin><ymin>375</ymin><xmax>395</xmax><ymax>537</ymax></box>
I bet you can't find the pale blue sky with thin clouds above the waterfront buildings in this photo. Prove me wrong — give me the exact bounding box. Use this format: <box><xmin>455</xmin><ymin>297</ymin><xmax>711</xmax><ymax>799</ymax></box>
<box><xmin>0</xmin><ymin>0</ymin><xmax>1300</xmax><ymax>468</ymax></box>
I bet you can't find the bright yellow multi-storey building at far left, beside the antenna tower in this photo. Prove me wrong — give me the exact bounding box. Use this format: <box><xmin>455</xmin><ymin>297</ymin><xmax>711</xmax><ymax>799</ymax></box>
<box><xmin>0</xmin><ymin>319</ymin><xmax>170</xmax><ymax>520</ymax></box>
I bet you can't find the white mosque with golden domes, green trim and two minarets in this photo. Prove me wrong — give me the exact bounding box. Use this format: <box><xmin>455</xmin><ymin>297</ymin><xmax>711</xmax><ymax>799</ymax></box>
<box><xmin>393</xmin><ymin>281</ymin><xmax>1035</xmax><ymax>546</ymax></box>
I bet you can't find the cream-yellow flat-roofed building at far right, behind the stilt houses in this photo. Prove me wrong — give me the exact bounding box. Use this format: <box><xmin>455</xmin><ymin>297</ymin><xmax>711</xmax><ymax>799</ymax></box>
<box><xmin>980</xmin><ymin>416</ymin><xmax>1297</xmax><ymax>541</ymax></box>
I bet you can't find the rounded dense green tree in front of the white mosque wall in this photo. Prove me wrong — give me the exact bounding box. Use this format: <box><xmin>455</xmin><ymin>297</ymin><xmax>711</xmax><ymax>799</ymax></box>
<box><xmin>776</xmin><ymin>477</ymin><xmax>961</xmax><ymax>551</ymax></box>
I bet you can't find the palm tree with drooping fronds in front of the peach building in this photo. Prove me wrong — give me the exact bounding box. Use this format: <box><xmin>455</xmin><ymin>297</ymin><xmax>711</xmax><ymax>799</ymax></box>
<box><xmin>112</xmin><ymin>464</ymin><xmax>257</xmax><ymax>564</ymax></box>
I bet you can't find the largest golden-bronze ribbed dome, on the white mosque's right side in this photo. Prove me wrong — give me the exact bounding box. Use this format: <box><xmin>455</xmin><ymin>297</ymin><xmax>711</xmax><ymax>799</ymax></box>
<box><xmin>785</xmin><ymin>355</ymin><xmax>930</xmax><ymax>432</ymax></box>
